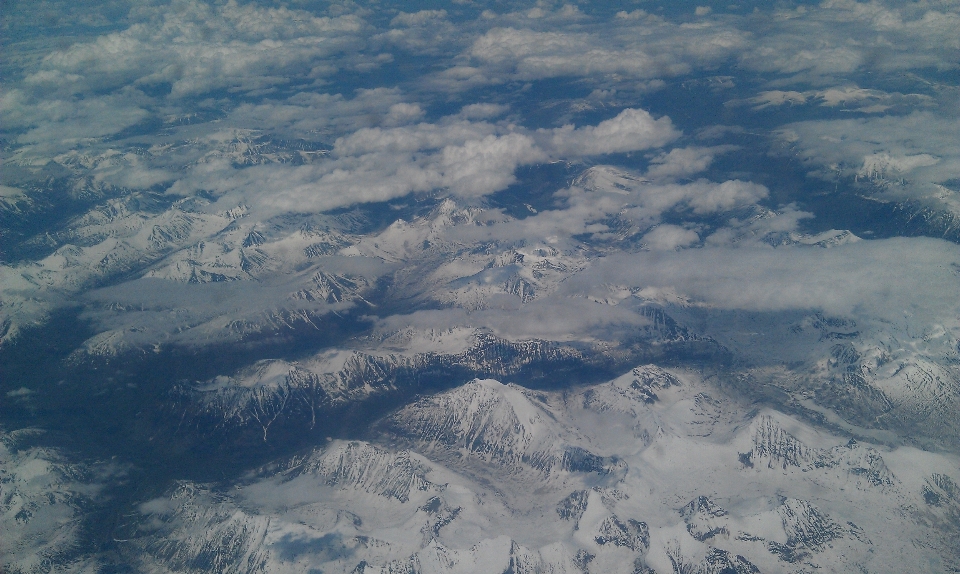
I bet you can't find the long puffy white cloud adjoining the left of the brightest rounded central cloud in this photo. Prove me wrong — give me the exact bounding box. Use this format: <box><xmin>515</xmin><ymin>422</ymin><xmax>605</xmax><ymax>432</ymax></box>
<box><xmin>170</xmin><ymin>120</ymin><xmax>548</xmax><ymax>214</ymax></box>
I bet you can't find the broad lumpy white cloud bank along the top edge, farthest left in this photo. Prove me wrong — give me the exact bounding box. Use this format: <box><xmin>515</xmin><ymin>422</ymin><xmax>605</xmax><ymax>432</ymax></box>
<box><xmin>24</xmin><ymin>0</ymin><xmax>366</xmax><ymax>97</ymax></box>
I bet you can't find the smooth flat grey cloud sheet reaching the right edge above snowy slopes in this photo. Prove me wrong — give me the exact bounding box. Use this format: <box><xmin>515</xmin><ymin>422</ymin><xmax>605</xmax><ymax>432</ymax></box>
<box><xmin>567</xmin><ymin>238</ymin><xmax>960</xmax><ymax>322</ymax></box>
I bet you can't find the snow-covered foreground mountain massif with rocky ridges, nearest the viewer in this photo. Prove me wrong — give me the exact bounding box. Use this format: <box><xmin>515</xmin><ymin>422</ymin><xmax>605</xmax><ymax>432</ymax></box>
<box><xmin>120</xmin><ymin>365</ymin><xmax>960</xmax><ymax>574</ymax></box>
